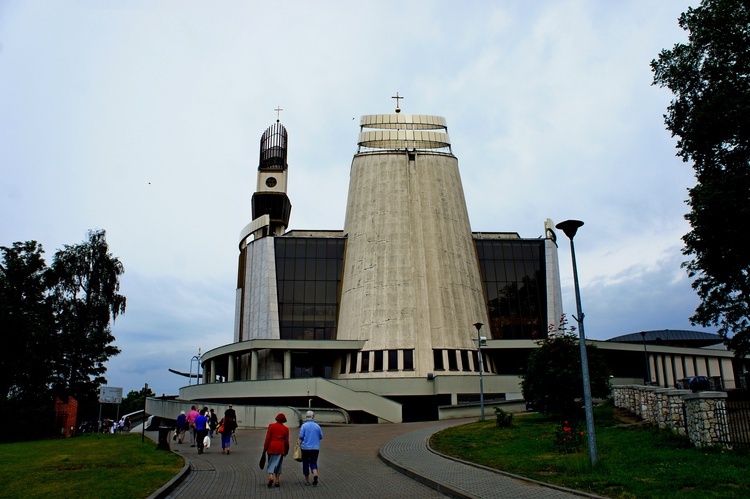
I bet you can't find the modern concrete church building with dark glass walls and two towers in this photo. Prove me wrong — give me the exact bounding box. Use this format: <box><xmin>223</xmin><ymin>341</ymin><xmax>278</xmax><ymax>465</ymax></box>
<box><xmin>150</xmin><ymin>103</ymin><xmax>733</xmax><ymax>426</ymax></box>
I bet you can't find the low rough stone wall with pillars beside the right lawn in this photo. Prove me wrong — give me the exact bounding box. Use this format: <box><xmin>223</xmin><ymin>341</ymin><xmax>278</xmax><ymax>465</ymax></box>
<box><xmin>612</xmin><ymin>385</ymin><xmax>731</xmax><ymax>447</ymax></box>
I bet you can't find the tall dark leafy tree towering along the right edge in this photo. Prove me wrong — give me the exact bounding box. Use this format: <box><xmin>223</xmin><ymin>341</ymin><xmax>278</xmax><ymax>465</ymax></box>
<box><xmin>651</xmin><ymin>0</ymin><xmax>750</xmax><ymax>357</ymax></box>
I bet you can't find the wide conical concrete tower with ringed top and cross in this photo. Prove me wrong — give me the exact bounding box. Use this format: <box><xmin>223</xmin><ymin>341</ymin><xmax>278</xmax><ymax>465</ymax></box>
<box><xmin>337</xmin><ymin>109</ymin><xmax>488</xmax><ymax>378</ymax></box>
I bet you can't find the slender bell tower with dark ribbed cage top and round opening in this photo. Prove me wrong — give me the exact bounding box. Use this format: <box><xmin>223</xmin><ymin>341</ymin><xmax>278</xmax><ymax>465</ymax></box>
<box><xmin>252</xmin><ymin>107</ymin><xmax>292</xmax><ymax>236</ymax></box>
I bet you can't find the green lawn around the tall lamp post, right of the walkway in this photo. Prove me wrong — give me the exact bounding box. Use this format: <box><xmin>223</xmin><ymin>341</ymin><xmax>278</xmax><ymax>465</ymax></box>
<box><xmin>430</xmin><ymin>406</ymin><xmax>750</xmax><ymax>498</ymax></box>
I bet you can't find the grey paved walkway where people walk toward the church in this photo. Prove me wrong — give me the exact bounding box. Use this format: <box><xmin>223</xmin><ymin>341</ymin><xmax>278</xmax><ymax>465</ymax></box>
<box><xmin>152</xmin><ymin>420</ymin><xmax>593</xmax><ymax>499</ymax></box>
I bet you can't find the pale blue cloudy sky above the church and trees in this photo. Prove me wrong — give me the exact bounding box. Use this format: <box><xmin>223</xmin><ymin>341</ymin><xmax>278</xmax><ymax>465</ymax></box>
<box><xmin>0</xmin><ymin>0</ymin><xmax>704</xmax><ymax>394</ymax></box>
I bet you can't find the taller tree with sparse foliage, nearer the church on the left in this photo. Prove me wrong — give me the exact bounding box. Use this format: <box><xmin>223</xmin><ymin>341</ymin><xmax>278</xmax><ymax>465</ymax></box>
<box><xmin>49</xmin><ymin>230</ymin><xmax>125</xmax><ymax>401</ymax></box>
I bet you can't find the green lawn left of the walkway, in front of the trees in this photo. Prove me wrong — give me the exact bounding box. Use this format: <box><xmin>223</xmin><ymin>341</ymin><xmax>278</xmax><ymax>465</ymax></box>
<box><xmin>0</xmin><ymin>434</ymin><xmax>184</xmax><ymax>498</ymax></box>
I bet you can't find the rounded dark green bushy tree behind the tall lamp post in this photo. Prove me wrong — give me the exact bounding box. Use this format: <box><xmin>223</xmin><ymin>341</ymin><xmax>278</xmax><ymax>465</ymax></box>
<box><xmin>521</xmin><ymin>315</ymin><xmax>610</xmax><ymax>421</ymax></box>
